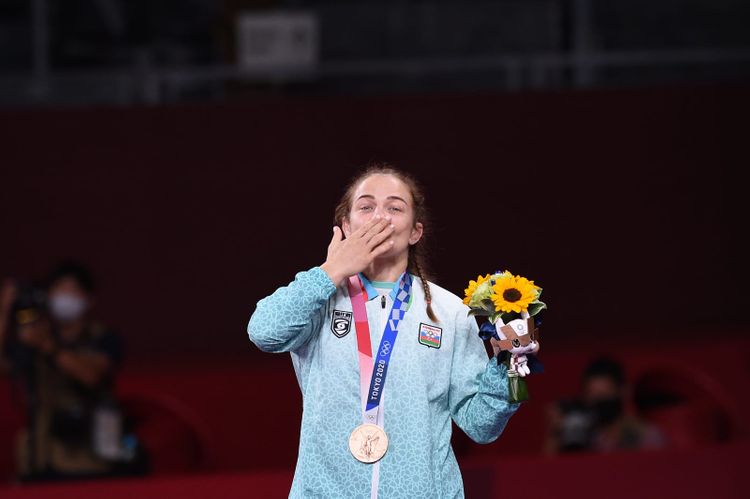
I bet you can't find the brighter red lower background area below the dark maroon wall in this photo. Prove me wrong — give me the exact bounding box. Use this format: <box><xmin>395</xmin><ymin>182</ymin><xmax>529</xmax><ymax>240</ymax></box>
<box><xmin>0</xmin><ymin>339</ymin><xmax>750</xmax><ymax>498</ymax></box>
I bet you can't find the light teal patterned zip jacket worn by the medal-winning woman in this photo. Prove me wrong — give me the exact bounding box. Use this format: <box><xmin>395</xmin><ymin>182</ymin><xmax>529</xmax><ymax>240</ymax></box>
<box><xmin>247</xmin><ymin>267</ymin><xmax>520</xmax><ymax>499</ymax></box>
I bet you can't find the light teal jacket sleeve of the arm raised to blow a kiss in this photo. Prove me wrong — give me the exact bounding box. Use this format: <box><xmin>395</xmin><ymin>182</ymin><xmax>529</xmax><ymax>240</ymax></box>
<box><xmin>247</xmin><ymin>267</ymin><xmax>336</xmax><ymax>352</ymax></box>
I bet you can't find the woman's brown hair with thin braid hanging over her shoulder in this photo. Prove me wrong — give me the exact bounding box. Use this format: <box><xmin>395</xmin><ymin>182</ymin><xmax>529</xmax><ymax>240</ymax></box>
<box><xmin>334</xmin><ymin>163</ymin><xmax>439</xmax><ymax>322</ymax></box>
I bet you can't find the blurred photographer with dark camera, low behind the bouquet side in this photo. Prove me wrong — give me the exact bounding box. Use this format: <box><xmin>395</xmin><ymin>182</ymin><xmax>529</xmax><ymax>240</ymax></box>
<box><xmin>545</xmin><ymin>357</ymin><xmax>664</xmax><ymax>454</ymax></box>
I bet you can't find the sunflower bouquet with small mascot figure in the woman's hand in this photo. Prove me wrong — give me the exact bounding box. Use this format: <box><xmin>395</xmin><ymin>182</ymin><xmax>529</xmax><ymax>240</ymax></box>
<box><xmin>464</xmin><ymin>270</ymin><xmax>547</xmax><ymax>402</ymax></box>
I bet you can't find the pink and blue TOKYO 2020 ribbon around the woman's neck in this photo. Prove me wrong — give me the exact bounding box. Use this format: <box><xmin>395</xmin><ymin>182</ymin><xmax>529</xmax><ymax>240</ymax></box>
<box><xmin>349</xmin><ymin>272</ymin><xmax>412</xmax><ymax>424</ymax></box>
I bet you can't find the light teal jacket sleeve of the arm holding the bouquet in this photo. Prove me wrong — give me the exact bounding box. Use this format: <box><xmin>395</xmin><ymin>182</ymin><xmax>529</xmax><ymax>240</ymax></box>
<box><xmin>449</xmin><ymin>307</ymin><xmax>521</xmax><ymax>444</ymax></box>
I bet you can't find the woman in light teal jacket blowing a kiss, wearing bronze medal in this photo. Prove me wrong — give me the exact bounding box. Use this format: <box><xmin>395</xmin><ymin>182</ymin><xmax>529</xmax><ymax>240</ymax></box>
<box><xmin>247</xmin><ymin>165</ymin><xmax>519</xmax><ymax>499</ymax></box>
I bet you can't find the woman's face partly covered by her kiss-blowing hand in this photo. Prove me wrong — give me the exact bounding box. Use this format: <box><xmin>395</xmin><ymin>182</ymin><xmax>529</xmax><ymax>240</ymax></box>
<box><xmin>342</xmin><ymin>174</ymin><xmax>423</xmax><ymax>258</ymax></box>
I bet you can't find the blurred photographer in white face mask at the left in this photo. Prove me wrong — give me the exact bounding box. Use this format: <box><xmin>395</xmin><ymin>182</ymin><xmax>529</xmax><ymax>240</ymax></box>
<box><xmin>0</xmin><ymin>262</ymin><xmax>145</xmax><ymax>481</ymax></box>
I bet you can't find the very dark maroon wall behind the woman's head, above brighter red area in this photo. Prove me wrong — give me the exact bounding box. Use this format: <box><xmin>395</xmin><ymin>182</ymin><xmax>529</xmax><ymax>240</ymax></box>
<box><xmin>0</xmin><ymin>87</ymin><xmax>750</xmax><ymax>358</ymax></box>
